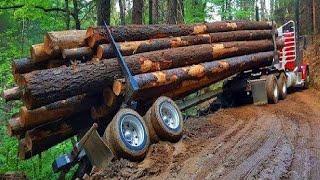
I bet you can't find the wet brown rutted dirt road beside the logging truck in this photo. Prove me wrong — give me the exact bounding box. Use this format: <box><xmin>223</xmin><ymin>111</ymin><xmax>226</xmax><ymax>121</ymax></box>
<box><xmin>93</xmin><ymin>90</ymin><xmax>320</xmax><ymax>179</ymax></box>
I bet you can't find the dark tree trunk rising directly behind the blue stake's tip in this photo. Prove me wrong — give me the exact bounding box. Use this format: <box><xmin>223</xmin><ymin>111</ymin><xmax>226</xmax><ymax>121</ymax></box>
<box><xmin>96</xmin><ymin>0</ymin><xmax>111</xmax><ymax>26</ymax></box>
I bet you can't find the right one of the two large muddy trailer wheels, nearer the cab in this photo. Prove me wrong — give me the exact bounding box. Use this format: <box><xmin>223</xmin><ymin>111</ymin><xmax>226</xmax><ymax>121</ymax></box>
<box><xmin>145</xmin><ymin>97</ymin><xmax>183</xmax><ymax>142</ymax></box>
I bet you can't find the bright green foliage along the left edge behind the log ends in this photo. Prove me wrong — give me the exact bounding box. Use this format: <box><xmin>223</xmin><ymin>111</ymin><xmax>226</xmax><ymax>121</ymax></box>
<box><xmin>0</xmin><ymin>0</ymin><xmax>75</xmax><ymax>179</ymax></box>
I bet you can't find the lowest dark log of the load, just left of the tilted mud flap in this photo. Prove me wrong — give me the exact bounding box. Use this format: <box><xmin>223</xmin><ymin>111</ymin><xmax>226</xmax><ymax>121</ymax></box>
<box><xmin>25</xmin><ymin>111</ymin><xmax>93</xmax><ymax>156</ymax></box>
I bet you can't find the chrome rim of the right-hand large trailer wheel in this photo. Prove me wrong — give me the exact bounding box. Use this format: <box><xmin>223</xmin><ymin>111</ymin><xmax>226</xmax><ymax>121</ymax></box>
<box><xmin>160</xmin><ymin>101</ymin><xmax>180</xmax><ymax>129</ymax></box>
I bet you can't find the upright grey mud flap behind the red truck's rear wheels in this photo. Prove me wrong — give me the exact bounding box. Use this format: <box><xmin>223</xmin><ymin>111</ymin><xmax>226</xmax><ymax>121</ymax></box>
<box><xmin>249</xmin><ymin>79</ymin><xmax>268</xmax><ymax>105</ymax></box>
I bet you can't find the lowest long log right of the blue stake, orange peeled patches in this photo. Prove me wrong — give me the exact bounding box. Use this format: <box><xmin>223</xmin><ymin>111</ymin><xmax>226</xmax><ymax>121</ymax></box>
<box><xmin>132</xmin><ymin>51</ymin><xmax>274</xmax><ymax>101</ymax></box>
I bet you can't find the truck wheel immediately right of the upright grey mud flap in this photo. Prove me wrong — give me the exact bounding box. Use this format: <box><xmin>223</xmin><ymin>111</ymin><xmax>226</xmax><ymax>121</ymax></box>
<box><xmin>266</xmin><ymin>75</ymin><xmax>279</xmax><ymax>104</ymax></box>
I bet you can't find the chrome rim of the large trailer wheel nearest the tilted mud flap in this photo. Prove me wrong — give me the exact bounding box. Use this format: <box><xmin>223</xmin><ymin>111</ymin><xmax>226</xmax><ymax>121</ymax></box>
<box><xmin>120</xmin><ymin>114</ymin><xmax>145</xmax><ymax>147</ymax></box>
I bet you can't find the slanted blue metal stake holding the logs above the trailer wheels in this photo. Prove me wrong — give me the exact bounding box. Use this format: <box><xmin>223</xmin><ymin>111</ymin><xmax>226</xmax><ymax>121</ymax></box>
<box><xmin>103</xmin><ymin>20</ymin><xmax>139</xmax><ymax>109</ymax></box>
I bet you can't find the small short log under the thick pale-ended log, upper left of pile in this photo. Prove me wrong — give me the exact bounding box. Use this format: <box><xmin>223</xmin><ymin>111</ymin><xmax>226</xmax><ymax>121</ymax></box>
<box><xmin>62</xmin><ymin>47</ymin><xmax>93</xmax><ymax>61</ymax></box>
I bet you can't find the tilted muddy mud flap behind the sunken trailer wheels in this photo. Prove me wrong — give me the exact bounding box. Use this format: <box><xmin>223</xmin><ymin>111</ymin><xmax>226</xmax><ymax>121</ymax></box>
<box><xmin>79</xmin><ymin>125</ymin><xmax>114</xmax><ymax>168</ymax></box>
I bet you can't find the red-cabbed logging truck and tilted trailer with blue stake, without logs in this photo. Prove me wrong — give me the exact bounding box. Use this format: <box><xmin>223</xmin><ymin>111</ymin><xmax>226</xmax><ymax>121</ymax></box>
<box><xmin>52</xmin><ymin>21</ymin><xmax>310</xmax><ymax>175</ymax></box>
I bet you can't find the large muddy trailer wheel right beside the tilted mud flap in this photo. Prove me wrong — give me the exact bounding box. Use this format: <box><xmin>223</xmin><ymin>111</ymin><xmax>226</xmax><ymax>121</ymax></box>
<box><xmin>104</xmin><ymin>108</ymin><xmax>150</xmax><ymax>161</ymax></box>
